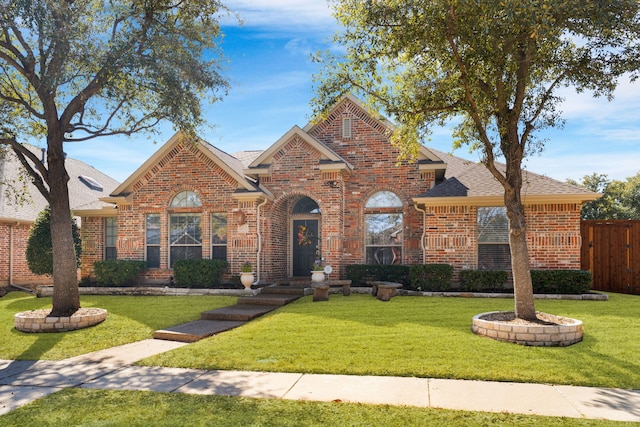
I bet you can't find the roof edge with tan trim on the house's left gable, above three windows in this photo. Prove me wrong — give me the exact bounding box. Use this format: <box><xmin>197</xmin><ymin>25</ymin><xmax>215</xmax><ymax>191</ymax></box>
<box><xmin>103</xmin><ymin>132</ymin><xmax>268</xmax><ymax>203</ymax></box>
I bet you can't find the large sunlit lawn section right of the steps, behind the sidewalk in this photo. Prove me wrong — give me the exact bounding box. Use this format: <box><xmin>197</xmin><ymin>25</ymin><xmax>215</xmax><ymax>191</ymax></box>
<box><xmin>140</xmin><ymin>294</ymin><xmax>640</xmax><ymax>389</ymax></box>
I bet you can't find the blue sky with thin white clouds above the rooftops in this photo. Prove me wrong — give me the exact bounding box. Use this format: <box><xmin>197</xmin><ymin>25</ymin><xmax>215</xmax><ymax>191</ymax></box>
<box><xmin>65</xmin><ymin>0</ymin><xmax>640</xmax><ymax>186</ymax></box>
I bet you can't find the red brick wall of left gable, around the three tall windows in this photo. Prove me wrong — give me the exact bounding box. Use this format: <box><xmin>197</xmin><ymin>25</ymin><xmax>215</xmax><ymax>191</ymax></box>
<box><xmin>83</xmin><ymin>143</ymin><xmax>257</xmax><ymax>283</ymax></box>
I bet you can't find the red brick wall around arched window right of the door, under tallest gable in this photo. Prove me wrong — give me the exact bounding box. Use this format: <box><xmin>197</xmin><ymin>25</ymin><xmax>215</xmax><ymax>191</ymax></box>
<box><xmin>302</xmin><ymin>103</ymin><xmax>435</xmax><ymax>276</ymax></box>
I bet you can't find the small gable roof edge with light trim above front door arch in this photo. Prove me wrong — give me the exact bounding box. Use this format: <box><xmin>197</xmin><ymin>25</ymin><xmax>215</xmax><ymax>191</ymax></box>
<box><xmin>244</xmin><ymin>126</ymin><xmax>353</xmax><ymax>175</ymax></box>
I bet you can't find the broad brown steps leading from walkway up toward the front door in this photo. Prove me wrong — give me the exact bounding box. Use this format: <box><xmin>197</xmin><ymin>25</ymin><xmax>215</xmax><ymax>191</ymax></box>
<box><xmin>153</xmin><ymin>286</ymin><xmax>305</xmax><ymax>343</ymax></box>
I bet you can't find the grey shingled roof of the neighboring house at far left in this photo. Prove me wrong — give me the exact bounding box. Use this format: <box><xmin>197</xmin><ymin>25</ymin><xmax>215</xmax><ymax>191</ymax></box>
<box><xmin>0</xmin><ymin>145</ymin><xmax>118</xmax><ymax>222</ymax></box>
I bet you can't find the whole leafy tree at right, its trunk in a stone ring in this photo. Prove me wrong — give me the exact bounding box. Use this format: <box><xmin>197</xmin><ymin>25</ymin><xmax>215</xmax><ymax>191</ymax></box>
<box><xmin>314</xmin><ymin>0</ymin><xmax>639</xmax><ymax>320</ymax></box>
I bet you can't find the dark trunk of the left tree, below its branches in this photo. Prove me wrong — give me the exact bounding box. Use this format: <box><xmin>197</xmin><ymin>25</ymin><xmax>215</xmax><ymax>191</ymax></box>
<box><xmin>47</xmin><ymin>135</ymin><xmax>80</xmax><ymax>316</ymax></box>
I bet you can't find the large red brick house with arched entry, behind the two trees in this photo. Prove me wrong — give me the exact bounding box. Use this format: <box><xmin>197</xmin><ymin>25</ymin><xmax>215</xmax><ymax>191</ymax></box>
<box><xmin>76</xmin><ymin>96</ymin><xmax>598</xmax><ymax>283</ymax></box>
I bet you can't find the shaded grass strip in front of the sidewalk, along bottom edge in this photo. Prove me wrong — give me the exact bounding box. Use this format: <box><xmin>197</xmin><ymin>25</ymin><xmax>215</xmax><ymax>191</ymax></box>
<box><xmin>0</xmin><ymin>389</ymin><xmax>628</xmax><ymax>427</ymax></box>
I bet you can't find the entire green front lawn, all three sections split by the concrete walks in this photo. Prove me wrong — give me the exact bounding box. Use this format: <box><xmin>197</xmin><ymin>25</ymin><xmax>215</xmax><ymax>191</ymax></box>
<box><xmin>0</xmin><ymin>293</ymin><xmax>640</xmax><ymax>426</ymax></box>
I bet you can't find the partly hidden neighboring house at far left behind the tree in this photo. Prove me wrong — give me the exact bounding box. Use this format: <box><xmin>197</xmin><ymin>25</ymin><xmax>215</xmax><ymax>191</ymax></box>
<box><xmin>0</xmin><ymin>146</ymin><xmax>119</xmax><ymax>286</ymax></box>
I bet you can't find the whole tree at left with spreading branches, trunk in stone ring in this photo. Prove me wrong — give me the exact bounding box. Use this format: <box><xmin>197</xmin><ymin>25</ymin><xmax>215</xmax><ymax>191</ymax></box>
<box><xmin>0</xmin><ymin>0</ymin><xmax>228</xmax><ymax>316</ymax></box>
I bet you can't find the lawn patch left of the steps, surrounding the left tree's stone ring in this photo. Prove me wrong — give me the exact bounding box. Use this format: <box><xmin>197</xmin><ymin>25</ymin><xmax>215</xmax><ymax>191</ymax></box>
<box><xmin>0</xmin><ymin>292</ymin><xmax>237</xmax><ymax>360</ymax></box>
